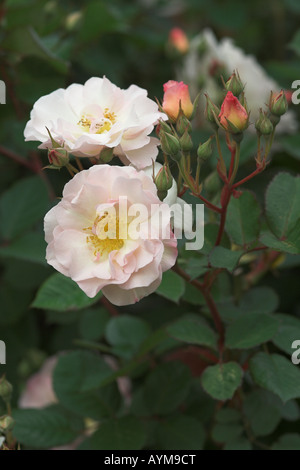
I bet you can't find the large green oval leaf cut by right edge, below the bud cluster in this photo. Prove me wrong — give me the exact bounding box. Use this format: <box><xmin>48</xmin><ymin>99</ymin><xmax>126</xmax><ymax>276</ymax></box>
<box><xmin>266</xmin><ymin>173</ymin><xmax>300</xmax><ymax>239</ymax></box>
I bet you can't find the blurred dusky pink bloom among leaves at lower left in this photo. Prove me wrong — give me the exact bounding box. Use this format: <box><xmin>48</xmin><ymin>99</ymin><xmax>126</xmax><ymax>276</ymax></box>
<box><xmin>19</xmin><ymin>356</ymin><xmax>58</xmax><ymax>408</ymax></box>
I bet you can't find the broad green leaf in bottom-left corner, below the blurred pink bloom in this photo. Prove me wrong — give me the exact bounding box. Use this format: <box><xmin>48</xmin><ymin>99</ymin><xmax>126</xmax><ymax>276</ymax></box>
<box><xmin>13</xmin><ymin>405</ymin><xmax>84</xmax><ymax>449</ymax></box>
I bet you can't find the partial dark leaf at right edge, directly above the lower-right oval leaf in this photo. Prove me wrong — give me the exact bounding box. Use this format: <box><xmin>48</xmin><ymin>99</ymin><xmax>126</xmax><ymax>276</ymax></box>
<box><xmin>272</xmin><ymin>313</ymin><xmax>300</xmax><ymax>355</ymax></box>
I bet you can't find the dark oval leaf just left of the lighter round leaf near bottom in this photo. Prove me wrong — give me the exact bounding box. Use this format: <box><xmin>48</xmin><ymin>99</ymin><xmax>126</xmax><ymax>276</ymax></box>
<box><xmin>144</xmin><ymin>362</ymin><xmax>191</xmax><ymax>415</ymax></box>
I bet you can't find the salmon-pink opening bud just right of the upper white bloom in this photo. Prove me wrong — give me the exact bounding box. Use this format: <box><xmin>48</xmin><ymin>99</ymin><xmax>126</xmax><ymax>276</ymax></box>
<box><xmin>162</xmin><ymin>80</ymin><xmax>194</xmax><ymax>121</ymax></box>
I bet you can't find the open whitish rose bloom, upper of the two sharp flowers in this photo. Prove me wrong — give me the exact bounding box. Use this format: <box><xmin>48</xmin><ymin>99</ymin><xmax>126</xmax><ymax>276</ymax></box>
<box><xmin>24</xmin><ymin>77</ymin><xmax>167</xmax><ymax>168</ymax></box>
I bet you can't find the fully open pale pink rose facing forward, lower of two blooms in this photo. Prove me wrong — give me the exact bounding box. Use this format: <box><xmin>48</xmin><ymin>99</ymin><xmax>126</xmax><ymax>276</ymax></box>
<box><xmin>44</xmin><ymin>165</ymin><xmax>177</xmax><ymax>305</ymax></box>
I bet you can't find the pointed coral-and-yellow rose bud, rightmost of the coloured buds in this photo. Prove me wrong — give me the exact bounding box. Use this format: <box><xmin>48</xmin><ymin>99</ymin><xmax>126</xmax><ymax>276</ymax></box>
<box><xmin>219</xmin><ymin>91</ymin><xmax>249</xmax><ymax>134</ymax></box>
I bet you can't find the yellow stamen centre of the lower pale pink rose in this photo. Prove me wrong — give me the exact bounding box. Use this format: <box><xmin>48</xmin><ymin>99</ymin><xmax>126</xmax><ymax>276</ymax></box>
<box><xmin>83</xmin><ymin>212</ymin><xmax>127</xmax><ymax>261</ymax></box>
